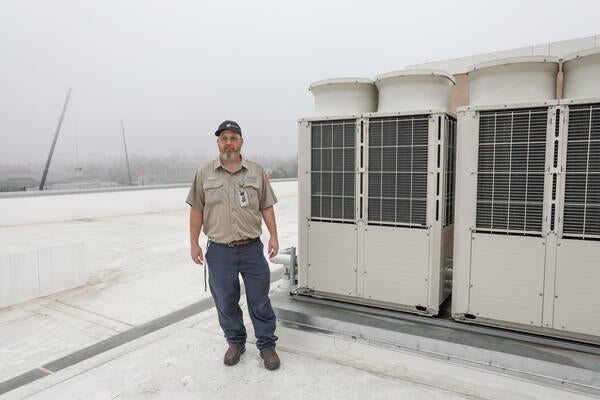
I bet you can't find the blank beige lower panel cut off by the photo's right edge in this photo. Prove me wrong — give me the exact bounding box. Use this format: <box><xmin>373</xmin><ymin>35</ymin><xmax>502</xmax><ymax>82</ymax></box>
<box><xmin>554</xmin><ymin>240</ymin><xmax>600</xmax><ymax>336</ymax></box>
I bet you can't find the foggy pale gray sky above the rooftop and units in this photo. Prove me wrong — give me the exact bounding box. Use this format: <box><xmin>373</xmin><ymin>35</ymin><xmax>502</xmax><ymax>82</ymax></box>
<box><xmin>0</xmin><ymin>0</ymin><xmax>600</xmax><ymax>164</ymax></box>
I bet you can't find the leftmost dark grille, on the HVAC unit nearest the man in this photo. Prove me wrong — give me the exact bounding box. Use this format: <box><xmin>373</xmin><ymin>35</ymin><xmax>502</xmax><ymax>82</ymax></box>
<box><xmin>311</xmin><ymin>120</ymin><xmax>356</xmax><ymax>222</ymax></box>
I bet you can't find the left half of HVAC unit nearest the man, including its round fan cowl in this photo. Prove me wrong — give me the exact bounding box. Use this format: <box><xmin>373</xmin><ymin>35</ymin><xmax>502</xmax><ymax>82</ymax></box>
<box><xmin>298</xmin><ymin>78</ymin><xmax>377</xmax><ymax>304</ymax></box>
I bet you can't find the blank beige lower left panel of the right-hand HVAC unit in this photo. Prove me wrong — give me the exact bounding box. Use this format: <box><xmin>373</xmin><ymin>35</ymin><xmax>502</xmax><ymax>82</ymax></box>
<box><xmin>469</xmin><ymin>233</ymin><xmax>546</xmax><ymax>326</ymax></box>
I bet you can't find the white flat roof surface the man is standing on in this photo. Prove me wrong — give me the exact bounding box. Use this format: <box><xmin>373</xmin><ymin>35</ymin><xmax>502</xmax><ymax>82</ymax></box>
<box><xmin>0</xmin><ymin>182</ymin><xmax>595</xmax><ymax>400</ymax></box>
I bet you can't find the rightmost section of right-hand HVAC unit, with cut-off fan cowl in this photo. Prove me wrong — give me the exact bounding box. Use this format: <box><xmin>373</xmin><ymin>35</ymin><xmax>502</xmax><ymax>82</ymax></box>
<box><xmin>550</xmin><ymin>48</ymin><xmax>600</xmax><ymax>343</ymax></box>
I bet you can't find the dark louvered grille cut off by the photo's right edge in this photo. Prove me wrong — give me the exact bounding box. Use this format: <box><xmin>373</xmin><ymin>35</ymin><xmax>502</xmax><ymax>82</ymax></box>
<box><xmin>563</xmin><ymin>104</ymin><xmax>600</xmax><ymax>239</ymax></box>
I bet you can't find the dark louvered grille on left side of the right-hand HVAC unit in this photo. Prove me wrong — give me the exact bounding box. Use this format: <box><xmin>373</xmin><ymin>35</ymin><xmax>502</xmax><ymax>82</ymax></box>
<box><xmin>476</xmin><ymin>108</ymin><xmax>548</xmax><ymax>236</ymax></box>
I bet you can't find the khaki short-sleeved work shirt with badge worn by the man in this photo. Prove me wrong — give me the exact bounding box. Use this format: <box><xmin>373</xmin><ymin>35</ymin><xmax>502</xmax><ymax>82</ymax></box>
<box><xmin>186</xmin><ymin>158</ymin><xmax>277</xmax><ymax>243</ymax></box>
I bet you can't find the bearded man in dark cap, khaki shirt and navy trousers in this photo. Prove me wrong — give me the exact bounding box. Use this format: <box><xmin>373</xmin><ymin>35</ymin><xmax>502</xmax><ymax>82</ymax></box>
<box><xmin>186</xmin><ymin>121</ymin><xmax>279</xmax><ymax>370</ymax></box>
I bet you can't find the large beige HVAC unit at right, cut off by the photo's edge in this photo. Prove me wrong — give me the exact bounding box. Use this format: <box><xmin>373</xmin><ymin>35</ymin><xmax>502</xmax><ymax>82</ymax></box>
<box><xmin>452</xmin><ymin>57</ymin><xmax>600</xmax><ymax>342</ymax></box>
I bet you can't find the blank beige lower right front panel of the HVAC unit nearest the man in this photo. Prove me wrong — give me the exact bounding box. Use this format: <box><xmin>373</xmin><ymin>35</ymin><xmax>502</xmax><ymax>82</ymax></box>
<box><xmin>364</xmin><ymin>226</ymin><xmax>428</xmax><ymax>309</ymax></box>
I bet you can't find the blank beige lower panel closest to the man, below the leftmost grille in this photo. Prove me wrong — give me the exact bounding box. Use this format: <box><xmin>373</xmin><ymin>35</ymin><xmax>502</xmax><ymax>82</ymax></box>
<box><xmin>307</xmin><ymin>221</ymin><xmax>357</xmax><ymax>296</ymax></box>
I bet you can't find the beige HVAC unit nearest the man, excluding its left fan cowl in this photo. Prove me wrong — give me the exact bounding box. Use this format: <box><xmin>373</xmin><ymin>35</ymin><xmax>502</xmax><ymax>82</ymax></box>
<box><xmin>297</xmin><ymin>71</ymin><xmax>456</xmax><ymax>315</ymax></box>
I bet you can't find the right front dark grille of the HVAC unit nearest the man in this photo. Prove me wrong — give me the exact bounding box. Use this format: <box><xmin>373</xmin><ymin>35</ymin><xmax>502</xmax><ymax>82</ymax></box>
<box><xmin>367</xmin><ymin>115</ymin><xmax>429</xmax><ymax>227</ymax></box>
